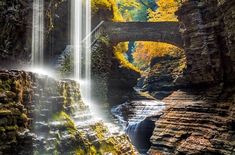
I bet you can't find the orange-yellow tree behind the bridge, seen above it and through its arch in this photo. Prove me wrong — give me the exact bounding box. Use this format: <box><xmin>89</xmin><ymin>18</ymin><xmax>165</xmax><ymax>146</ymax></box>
<box><xmin>133</xmin><ymin>0</ymin><xmax>183</xmax><ymax>68</ymax></box>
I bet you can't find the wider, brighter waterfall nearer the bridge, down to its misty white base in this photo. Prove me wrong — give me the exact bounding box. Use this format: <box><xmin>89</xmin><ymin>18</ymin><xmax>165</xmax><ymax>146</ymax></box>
<box><xmin>71</xmin><ymin>0</ymin><xmax>99</xmax><ymax>116</ymax></box>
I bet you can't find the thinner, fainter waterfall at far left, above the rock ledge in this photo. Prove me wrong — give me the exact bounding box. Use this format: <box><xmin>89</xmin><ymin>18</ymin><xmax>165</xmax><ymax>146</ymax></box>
<box><xmin>31</xmin><ymin>0</ymin><xmax>44</xmax><ymax>67</ymax></box>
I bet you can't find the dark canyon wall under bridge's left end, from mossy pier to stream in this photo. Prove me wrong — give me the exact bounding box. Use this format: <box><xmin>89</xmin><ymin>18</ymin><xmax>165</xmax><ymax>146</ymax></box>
<box><xmin>91</xmin><ymin>37</ymin><xmax>140</xmax><ymax>106</ymax></box>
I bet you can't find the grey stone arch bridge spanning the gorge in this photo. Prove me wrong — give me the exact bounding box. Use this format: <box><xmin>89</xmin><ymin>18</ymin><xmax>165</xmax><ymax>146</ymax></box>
<box><xmin>92</xmin><ymin>21</ymin><xmax>183</xmax><ymax>48</ymax></box>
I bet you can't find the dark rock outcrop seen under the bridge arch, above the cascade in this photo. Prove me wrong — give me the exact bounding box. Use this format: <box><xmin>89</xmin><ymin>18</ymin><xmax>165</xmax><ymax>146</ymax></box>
<box><xmin>138</xmin><ymin>52</ymin><xmax>185</xmax><ymax>99</ymax></box>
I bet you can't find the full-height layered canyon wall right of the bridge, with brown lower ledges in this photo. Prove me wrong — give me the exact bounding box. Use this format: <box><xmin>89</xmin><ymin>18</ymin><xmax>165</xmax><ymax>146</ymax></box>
<box><xmin>149</xmin><ymin>0</ymin><xmax>235</xmax><ymax>155</ymax></box>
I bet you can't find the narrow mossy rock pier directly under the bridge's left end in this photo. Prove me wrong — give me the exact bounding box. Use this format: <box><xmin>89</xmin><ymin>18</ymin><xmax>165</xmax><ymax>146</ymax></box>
<box><xmin>91</xmin><ymin>36</ymin><xmax>112</xmax><ymax>102</ymax></box>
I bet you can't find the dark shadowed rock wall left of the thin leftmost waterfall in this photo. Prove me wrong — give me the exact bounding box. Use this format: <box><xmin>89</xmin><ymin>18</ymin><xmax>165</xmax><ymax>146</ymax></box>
<box><xmin>0</xmin><ymin>0</ymin><xmax>32</xmax><ymax>68</ymax></box>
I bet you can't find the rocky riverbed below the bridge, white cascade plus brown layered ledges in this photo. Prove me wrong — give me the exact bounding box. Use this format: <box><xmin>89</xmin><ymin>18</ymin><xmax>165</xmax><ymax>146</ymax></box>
<box><xmin>112</xmin><ymin>88</ymin><xmax>235</xmax><ymax>155</ymax></box>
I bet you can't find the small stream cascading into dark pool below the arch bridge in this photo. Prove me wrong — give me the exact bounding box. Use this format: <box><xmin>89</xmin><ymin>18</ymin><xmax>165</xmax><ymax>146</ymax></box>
<box><xmin>111</xmin><ymin>89</ymin><xmax>165</xmax><ymax>155</ymax></box>
